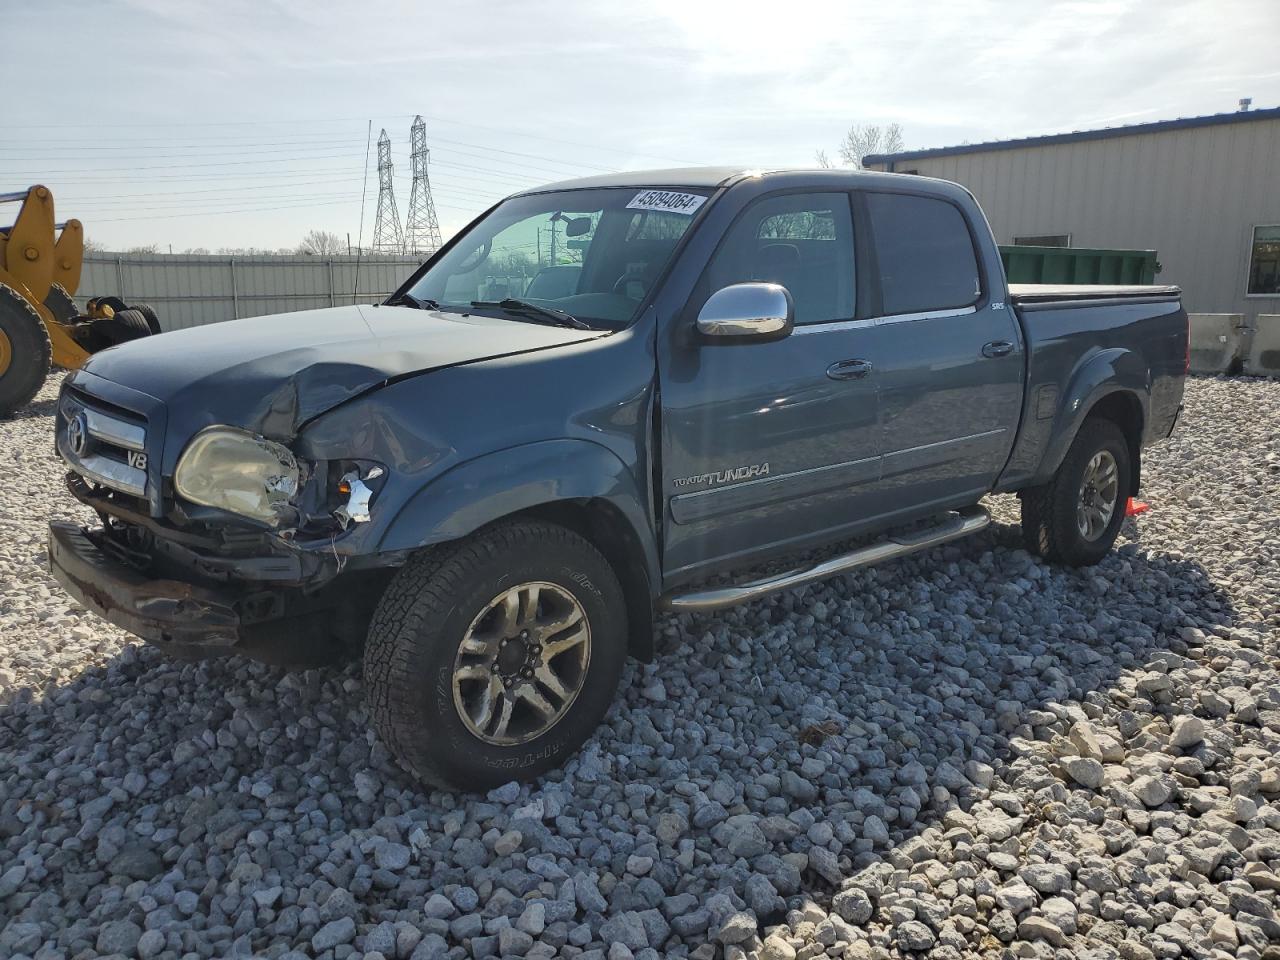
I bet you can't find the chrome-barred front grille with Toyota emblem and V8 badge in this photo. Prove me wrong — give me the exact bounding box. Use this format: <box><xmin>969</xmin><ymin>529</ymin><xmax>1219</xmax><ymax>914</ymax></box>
<box><xmin>58</xmin><ymin>390</ymin><xmax>147</xmax><ymax>499</ymax></box>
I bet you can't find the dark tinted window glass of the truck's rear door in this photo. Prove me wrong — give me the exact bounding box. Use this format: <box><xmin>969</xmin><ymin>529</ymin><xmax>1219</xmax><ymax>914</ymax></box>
<box><xmin>867</xmin><ymin>193</ymin><xmax>982</xmax><ymax>314</ymax></box>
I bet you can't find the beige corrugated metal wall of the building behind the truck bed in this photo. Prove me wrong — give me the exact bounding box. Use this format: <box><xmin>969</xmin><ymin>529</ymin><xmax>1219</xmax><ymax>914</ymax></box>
<box><xmin>860</xmin><ymin>119</ymin><xmax>1280</xmax><ymax>326</ymax></box>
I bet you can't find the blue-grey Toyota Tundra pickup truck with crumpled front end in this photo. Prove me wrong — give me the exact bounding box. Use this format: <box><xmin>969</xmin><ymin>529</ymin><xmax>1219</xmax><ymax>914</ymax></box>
<box><xmin>49</xmin><ymin>169</ymin><xmax>1188</xmax><ymax>788</ymax></box>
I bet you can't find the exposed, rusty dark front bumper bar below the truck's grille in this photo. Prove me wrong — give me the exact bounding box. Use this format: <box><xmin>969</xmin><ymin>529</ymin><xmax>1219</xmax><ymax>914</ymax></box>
<box><xmin>49</xmin><ymin>522</ymin><xmax>254</xmax><ymax>655</ymax></box>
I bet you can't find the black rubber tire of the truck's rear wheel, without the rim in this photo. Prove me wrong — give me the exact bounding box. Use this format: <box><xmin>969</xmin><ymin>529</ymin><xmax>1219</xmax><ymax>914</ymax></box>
<box><xmin>1019</xmin><ymin>419</ymin><xmax>1133</xmax><ymax>567</ymax></box>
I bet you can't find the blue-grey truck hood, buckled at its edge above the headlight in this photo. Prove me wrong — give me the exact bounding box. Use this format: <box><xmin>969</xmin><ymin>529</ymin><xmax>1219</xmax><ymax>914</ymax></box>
<box><xmin>84</xmin><ymin>305</ymin><xmax>605</xmax><ymax>439</ymax></box>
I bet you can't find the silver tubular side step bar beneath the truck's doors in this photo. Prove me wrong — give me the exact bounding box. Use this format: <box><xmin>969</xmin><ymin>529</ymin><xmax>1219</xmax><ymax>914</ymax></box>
<box><xmin>659</xmin><ymin>507</ymin><xmax>991</xmax><ymax>613</ymax></box>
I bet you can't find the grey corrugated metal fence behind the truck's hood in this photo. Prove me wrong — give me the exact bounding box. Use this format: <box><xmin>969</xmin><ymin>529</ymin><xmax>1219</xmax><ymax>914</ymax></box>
<box><xmin>77</xmin><ymin>253</ymin><xmax>421</xmax><ymax>330</ymax></box>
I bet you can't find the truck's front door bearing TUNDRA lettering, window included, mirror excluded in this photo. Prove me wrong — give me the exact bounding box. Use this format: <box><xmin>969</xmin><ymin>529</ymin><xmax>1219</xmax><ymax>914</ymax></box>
<box><xmin>659</xmin><ymin>192</ymin><xmax>879</xmax><ymax>580</ymax></box>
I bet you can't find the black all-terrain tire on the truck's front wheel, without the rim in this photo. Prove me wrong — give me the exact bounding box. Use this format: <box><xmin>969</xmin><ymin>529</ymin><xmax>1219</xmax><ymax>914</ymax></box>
<box><xmin>364</xmin><ymin>521</ymin><xmax>627</xmax><ymax>790</ymax></box>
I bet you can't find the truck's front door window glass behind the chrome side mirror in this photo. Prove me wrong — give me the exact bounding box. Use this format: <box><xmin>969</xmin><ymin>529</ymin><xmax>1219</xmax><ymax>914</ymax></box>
<box><xmin>707</xmin><ymin>193</ymin><xmax>854</xmax><ymax>324</ymax></box>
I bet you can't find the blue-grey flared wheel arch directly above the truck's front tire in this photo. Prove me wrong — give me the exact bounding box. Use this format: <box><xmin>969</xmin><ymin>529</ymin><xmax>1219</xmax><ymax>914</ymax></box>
<box><xmin>378</xmin><ymin>439</ymin><xmax>660</xmax><ymax>584</ymax></box>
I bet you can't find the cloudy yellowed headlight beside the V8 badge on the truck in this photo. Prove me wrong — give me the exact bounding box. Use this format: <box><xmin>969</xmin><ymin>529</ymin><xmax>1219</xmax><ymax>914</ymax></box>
<box><xmin>173</xmin><ymin>426</ymin><xmax>301</xmax><ymax>526</ymax></box>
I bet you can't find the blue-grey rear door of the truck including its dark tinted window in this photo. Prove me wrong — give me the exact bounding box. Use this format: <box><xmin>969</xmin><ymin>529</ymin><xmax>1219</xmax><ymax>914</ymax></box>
<box><xmin>859</xmin><ymin>191</ymin><xmax>1024</xmax><ymax>515</ymax></box>
